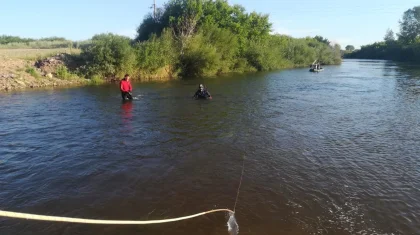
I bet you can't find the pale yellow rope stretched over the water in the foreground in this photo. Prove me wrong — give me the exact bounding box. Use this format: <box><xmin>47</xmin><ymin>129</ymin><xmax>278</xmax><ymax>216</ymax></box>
<box><xmin>0</xmin><ymin>209</ymin><xmax>234</xmax><ymax>224</ymax></box>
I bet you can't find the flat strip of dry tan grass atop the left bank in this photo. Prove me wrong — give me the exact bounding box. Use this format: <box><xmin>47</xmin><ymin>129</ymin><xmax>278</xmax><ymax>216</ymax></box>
<box><xmin>0</xmin><ymin>48</ymin><xmax>80</xmax><ymax>60</ymax></box>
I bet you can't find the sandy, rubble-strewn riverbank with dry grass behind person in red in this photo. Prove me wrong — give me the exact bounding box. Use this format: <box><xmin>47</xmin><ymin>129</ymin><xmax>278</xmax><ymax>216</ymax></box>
<box><xmin>0</xmin><ymin>54</ymin><xmax>177</xmax><ymax>91</ymax></box>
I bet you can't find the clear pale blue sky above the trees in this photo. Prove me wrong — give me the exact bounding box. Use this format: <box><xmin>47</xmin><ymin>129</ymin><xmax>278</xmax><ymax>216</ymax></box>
<box><xmin>0</xmin><ymin>0</ymin><xmax>420</xmax><ymax>48</ymax></box>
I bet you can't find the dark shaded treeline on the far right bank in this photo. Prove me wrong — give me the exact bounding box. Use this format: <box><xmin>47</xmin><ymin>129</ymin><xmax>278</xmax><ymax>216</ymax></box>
<box><xmin>345</xmin><ymin>6</ymin><xmax>420</xmax><ymax>62</ymax></box>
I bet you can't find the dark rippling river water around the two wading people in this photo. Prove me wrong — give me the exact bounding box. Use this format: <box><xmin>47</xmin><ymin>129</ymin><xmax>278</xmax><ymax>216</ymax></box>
<box><xmin>0</xmin><ymin>60</ymin><xmax>420</xmax><ymax>235</ymax></box>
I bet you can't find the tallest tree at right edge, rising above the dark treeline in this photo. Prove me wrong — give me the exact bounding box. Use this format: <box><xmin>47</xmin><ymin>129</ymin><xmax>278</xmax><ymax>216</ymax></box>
<box><xmin>398</xmin><ymin>6</ymin><xmax>420</xmax><ymax>44</ymax></box>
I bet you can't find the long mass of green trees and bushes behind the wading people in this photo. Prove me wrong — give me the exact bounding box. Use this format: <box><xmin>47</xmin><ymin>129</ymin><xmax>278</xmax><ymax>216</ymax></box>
<box><xmin>79</xmin><ymin>0</ymin><xmax>341</xmax><ymax>78</ymax></box>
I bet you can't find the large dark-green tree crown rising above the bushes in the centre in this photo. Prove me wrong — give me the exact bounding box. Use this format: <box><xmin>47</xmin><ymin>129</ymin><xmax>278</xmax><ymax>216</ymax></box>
<box><xmin>137</xmin><ymin>0</ymin><xmax>272</xmax><ymax>46</ymax></box>
